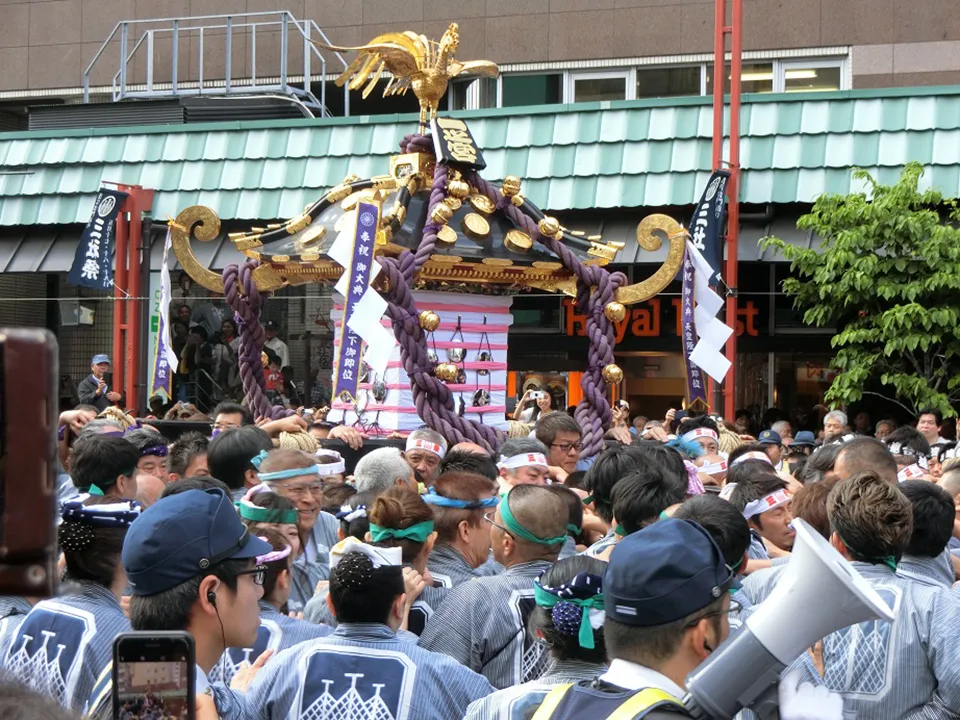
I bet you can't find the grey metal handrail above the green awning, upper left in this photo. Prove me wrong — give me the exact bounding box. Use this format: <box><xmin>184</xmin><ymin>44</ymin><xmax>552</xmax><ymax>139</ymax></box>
<box><xmin>83</xmin><ymin>10</ymin><xmax>350</xmax><ymax>115</ymax></box>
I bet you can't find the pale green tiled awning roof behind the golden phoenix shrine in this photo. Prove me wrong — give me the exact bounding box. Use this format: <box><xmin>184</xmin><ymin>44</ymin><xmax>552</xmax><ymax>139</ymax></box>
<box><xmin>0</xmin><ymin>87</ymin><xmax>960</xmax><ymax>225</ymax></box>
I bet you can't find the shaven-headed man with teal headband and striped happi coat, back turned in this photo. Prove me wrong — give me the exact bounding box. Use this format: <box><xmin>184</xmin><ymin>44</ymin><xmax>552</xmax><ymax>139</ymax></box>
<box><xmin>420</xmin><ymin>485</ymin><xmax>567</xmax><ymax>689</ymax></box>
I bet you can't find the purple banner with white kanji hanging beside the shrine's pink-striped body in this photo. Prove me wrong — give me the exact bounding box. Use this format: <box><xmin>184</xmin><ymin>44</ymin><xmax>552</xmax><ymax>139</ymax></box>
<box><xmin>334</xmin><ymin>202</ymin><xmax>380</xmax><ymax>401</ymax></box>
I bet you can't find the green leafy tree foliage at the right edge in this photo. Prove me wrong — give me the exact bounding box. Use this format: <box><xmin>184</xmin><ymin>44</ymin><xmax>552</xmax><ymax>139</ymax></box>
<box><xmin>763</xmin><ymin>163</ymin><xmax>960</xmax><ymax>415</ymax></box>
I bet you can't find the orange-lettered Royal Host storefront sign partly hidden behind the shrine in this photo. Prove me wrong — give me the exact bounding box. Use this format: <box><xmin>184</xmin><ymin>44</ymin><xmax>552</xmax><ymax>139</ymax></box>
<box><xmin>564</xmin><ymin>297</ymin><xmax>760</xmax><ymax>344</ymax></box>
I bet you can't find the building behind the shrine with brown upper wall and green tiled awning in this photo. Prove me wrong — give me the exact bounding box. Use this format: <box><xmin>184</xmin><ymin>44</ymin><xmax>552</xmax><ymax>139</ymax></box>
<box><xmin>0</xmin><ymin>0</ymin><xmax>960</xmax><ymax>415</ymax></box>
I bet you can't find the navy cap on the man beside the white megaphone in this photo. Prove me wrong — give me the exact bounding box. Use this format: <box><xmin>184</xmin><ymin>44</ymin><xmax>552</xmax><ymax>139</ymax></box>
<box><xmin>604</xmin><ymin>518</ymin><xmax>734</xmax><ymax>627</ymax></box>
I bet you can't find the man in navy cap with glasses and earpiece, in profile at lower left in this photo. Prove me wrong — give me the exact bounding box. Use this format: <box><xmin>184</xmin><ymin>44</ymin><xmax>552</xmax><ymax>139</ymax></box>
<box><xmin>90</xmin><ymin>490</ymin><xmax>272</xmax><ymax>718</ymax></box>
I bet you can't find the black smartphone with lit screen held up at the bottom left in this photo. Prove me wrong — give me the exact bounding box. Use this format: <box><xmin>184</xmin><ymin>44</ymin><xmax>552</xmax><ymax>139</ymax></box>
<box><xmin>113</xmin><ymin>632</ymin><xmax>196</xmax><ymax>720</ymax></box>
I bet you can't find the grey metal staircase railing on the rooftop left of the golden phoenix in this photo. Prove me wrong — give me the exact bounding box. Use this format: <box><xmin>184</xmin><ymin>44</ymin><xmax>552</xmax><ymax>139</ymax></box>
<box><xmin>83</xmin><ymin>10</ymin><xmax>350</xmax><ymax>116</ymax></box>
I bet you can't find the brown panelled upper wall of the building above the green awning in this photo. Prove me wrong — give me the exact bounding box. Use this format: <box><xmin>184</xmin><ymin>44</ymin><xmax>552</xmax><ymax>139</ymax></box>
<box><xmin>0</xmin><ymin>0</ymin><xmax>960</xmax><ymax>91</ymax></box>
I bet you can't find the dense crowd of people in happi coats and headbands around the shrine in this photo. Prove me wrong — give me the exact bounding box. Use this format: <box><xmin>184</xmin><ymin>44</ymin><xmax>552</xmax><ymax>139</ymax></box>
<box><xmin>0</xmin><ymin>376</ymin><xmax>960</xmax><ymax>720</ymax></box>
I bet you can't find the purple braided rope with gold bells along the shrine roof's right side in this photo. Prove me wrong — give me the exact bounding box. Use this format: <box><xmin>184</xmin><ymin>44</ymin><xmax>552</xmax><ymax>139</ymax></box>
<box><xmin>466</xmin><ymin>172</ymin><xmax>627</xmax><ymax>457</ymax></box>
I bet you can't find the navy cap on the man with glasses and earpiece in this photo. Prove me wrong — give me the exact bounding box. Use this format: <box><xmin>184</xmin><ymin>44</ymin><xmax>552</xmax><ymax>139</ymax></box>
<box><xmin>121</xmin><ymin>489</ymin><xmax>273</xmax><ymax>595</ymax></box>
